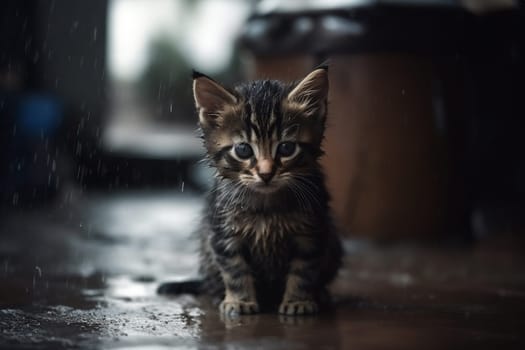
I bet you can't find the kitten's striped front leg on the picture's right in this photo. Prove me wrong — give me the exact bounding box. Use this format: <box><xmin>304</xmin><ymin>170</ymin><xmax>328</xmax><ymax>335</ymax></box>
<box><xmin>279</xmin><ymin>238</ymin><xmax>319</xmax><ymax>315</ymax></box>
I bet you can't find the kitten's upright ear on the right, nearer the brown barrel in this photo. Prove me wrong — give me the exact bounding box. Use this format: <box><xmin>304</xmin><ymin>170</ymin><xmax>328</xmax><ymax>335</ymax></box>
<box><xmin>288</xmin><ymin>66</ymin><xmax>328</xmax><ymax>115</ymax></box>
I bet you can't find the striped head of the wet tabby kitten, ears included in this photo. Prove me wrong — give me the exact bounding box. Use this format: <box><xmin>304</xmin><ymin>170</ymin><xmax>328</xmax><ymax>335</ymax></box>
<box><xmin>193</xmin><ymin>67</ymin><xmax>328</xmax><ymax>193</ymax></box>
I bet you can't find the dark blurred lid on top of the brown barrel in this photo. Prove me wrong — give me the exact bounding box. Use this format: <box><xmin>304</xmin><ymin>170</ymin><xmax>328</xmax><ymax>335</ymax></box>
<box><xmin>239</xmin><ymin>0</ymin><xmax>474</xmax><ymax>56</ymax></box>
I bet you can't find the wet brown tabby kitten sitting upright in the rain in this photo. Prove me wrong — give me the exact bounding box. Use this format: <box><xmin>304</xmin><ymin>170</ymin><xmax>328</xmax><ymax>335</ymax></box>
<box><xmin>158</xmin><ymin>67</ymin><xmax>342</xmax><ymax>315</ymax></box>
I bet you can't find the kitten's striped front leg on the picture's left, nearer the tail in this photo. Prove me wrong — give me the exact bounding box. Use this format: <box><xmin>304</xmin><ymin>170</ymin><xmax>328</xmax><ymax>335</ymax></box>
<box><xmin>211</xmin><ymin>238</ymin><xmax>259</xmax><ymax>315</ymax></box>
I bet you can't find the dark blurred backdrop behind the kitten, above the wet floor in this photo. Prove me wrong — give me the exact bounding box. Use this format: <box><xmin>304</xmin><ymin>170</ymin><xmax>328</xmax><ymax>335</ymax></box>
<box><xmin>0</xmin><ymin>0</ymin><xmax>525</xmax><ymax>239</ymax></box>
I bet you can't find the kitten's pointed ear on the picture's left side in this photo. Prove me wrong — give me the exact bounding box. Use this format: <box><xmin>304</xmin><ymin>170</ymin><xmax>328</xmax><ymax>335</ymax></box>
<box><xmin>193</xmin><ymin>71</ymin><xmax>237</xmax><ymax>127</ymax></box>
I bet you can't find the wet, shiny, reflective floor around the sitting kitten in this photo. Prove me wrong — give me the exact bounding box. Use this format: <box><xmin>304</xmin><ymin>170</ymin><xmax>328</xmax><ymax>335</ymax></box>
<box><xmin>0</xmin><ymin>190</ymin><xmax>525</xmax><ymax>350</ymax></box>
